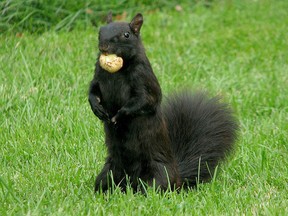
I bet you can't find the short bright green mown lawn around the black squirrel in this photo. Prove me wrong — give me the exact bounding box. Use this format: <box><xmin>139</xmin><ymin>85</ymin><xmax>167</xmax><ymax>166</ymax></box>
<box><xmin>0</xmin><ymin>0</ymin><xmax>288</xmax><ymax>215</ymax></box>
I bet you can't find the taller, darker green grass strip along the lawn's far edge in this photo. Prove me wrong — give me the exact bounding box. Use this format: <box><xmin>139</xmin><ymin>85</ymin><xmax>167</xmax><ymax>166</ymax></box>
<box><xmin>0</xmin><ymin>0</ymin><xmax>196</xmax><ymax>33</ymax></box>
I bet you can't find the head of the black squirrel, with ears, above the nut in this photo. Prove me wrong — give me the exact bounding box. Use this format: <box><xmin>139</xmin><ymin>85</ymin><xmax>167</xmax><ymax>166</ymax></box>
<box><xmin>99</xmin><ymin>13</ymin><xmax>143</xmax><ymax>61</ymax></box>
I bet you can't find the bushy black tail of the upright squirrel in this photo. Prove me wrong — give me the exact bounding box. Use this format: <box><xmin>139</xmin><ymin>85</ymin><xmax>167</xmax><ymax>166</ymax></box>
<box><xmin>163</xmin><ymin>91</ymin><xmax>237</xmax><ymax>186</ymax></box>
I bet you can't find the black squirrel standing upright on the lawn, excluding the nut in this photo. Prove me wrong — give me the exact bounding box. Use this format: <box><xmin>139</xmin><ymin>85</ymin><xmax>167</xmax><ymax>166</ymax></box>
<box><xmin>89</xmin><ymin>14</ymin><xmax>237</xmax><ymax>191</ymax></box>
